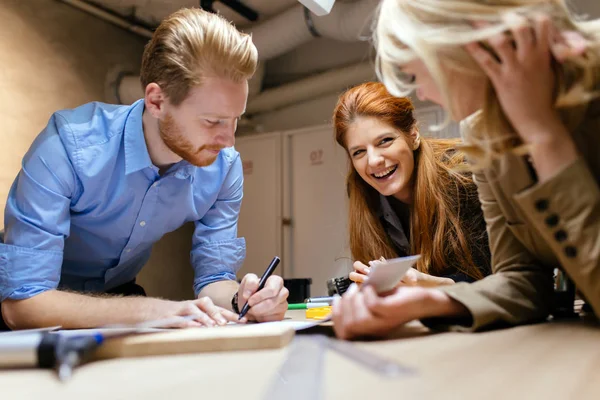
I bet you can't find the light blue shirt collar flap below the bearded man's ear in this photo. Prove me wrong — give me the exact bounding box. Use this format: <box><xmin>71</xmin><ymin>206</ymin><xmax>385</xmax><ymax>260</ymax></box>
<box><xmin>124</xmin><ymin>99</ymin><xmax>152</xmax><ymax>175</ymax></box>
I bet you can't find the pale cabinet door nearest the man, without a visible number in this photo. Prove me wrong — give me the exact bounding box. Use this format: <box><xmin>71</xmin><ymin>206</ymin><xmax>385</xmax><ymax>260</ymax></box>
<box><xmin>235</xmin><ymin>133</ymin><xmax>285</xmax><ymax>279</ymax></box>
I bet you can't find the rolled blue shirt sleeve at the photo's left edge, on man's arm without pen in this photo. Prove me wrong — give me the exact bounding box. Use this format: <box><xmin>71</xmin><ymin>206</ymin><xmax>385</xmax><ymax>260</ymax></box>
<box><xmin>0</xmin><ymin>114</ymin><xmax>78</xmax><ymax>301</ymax></box>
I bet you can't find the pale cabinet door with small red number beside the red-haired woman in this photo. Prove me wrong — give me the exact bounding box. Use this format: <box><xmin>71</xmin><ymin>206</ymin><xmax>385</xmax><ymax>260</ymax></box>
<box><xmin>283</xmin><ymin>126</ymin><xmax>351</xmax><ymax>296</ymax></box>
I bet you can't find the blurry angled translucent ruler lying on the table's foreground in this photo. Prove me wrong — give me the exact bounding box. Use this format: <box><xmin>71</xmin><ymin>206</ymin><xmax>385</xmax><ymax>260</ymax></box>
<box><xmin>264</xmin><ymin>335</ymin><xmax>415</xmax><ymax>400</ymax></box>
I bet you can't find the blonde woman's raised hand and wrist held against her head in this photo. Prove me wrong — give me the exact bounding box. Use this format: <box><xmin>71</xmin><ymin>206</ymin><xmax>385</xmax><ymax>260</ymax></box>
<box><xmin>466</xmin><ymin>16</ymin><xmax>587</xmax><ymax>183</ymax></box>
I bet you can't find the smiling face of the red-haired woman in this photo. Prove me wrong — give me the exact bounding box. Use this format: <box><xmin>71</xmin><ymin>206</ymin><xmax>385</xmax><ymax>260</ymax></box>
<box><xmin>346</xmin><ymin>117</ymin><xmax>415</xmax><ymax>203</ymax></box>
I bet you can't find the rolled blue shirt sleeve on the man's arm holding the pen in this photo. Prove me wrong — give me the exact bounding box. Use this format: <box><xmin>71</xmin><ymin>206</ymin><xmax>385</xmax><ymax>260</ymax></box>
<box><xmin>191</xmin><ymin>153</ymin><xmax>246</xmax><ymax>296</ymax></box>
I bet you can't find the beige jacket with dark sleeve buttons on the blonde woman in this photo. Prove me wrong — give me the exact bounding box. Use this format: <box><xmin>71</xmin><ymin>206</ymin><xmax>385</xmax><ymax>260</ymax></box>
<box><xmin>426</xmin><ymin>101</ymin><xmax>600</xmax><ymax>330</ymax></box>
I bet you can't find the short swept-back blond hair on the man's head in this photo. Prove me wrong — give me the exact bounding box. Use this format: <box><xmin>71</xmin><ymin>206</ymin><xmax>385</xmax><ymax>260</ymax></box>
<box><xmin>140</xmin><ymin>8</ymin><xmax>258</xmax><ymax>105</ymax></box>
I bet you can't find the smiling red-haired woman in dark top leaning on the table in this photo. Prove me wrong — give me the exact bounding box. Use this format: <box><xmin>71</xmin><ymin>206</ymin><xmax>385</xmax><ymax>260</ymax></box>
<box><xmin>333</xmin><ymin>82</ymin><xmax>490</xmax><ymax>286</ymax></box>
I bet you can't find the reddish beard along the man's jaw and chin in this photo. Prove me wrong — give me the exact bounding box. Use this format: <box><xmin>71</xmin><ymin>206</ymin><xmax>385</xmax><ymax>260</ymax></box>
<box><xmin>158</xmin><ymin>114</ymin><xmax>221</xmax><ymax>167</ymax></box>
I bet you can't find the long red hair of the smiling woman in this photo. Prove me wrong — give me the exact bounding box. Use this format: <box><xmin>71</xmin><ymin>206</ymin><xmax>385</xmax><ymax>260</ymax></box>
<box><xmin>333</xmin><ymin>82</ymin><xmax>483</xmax><ymax>279</ymax></box>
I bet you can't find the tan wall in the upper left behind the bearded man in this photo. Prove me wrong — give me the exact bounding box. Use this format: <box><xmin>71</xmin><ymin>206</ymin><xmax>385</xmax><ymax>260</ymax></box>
<box><xmin>0</xmin><ymin>0</ymin><xmax>144</xmax><ymax>226</ymax></box>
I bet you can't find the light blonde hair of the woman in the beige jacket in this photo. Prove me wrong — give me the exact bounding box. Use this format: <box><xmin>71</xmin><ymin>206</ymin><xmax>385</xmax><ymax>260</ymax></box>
<box><xmin>374</xmin><ymin>0</ymin><xmax>600</xmax><ymax>166</ymax></box>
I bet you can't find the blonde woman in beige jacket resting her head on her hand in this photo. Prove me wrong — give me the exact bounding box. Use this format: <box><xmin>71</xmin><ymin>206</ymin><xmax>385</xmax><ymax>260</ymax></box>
<box><xmin>333</xmin><ymin>0</ymin><xmax>600</xmax><ymax>338</ymax></box>
